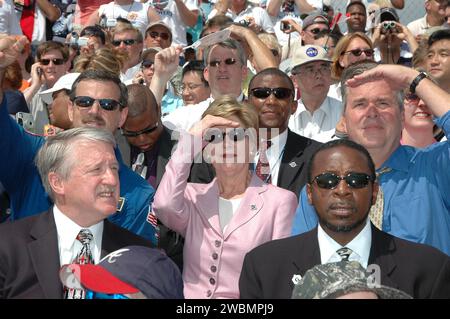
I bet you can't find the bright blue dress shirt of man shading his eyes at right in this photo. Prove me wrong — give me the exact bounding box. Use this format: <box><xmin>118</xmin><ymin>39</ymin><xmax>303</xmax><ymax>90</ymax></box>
<box><xmin>292</xmin><ymin>111</ymin><xmax>450</xmax><ymax>255</ymax></box>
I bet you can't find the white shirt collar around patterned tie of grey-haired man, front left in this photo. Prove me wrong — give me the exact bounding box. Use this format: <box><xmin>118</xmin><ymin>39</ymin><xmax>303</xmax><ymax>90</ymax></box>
<box><xmin>53</xmin><ymin>205</ymin><xmax>103</xmax><ymax>260</ymax></box>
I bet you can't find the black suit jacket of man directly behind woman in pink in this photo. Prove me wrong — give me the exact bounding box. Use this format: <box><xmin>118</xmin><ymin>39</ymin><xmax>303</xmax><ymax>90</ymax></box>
<box><xmin>190</xmin><ymin>129</ymin><xmax>322</xmax><ymax>198</ymax></box>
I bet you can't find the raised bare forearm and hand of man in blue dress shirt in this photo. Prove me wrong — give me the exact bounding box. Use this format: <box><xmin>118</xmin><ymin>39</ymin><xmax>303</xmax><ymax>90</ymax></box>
<box><xmin>347</xmin><ymin>64</ymin><xmax>450</xmax><ymax>117</ymax></box>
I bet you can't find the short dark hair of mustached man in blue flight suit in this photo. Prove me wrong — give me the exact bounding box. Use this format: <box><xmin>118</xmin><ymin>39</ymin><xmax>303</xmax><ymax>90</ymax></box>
<box><xmin>70</xmin><ymin>69</ymin><xmax>128</xmax><ymax>110</ymax></box>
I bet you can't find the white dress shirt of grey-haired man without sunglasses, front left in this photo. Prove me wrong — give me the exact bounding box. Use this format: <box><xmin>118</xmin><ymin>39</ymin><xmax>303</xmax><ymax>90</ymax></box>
<box><xmin>53</xmin><ymin>205</ymin><xmax>103</xmax><ymax>266</ymax></box>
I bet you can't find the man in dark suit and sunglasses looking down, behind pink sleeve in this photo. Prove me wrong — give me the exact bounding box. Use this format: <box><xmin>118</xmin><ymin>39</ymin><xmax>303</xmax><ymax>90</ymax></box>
<box><xmin>121</xmin><ymin>84</ymin><xmax>184</xmax><ymax>270</ymax></box>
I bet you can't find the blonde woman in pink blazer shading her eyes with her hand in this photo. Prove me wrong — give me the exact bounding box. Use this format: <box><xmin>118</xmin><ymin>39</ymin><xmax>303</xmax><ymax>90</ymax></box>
<box><xmin>153</xmin><ymin>97</ymin><xmax>298</xmax><ymax>298</ymax></box>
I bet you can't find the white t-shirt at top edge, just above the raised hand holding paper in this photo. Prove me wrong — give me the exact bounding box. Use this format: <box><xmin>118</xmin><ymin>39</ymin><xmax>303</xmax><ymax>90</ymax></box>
<box><xmin>147</xmin><ymin>0</ymin><xmax>199</xmax><ymax>46</ymax></box>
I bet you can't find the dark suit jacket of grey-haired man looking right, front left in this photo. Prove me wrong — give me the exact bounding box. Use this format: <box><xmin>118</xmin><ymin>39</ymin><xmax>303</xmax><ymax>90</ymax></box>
<box><xmin>0</xmin><ymin>208</ymin><xmax>151</xmax><ymax>299</ymax></box>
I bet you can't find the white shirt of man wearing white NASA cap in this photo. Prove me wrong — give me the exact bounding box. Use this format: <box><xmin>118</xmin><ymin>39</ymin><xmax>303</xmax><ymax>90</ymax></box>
<box><xmin>289</xmin><ymin>96</ymin><xmax>343</xmax><ymax>143</ymax></box>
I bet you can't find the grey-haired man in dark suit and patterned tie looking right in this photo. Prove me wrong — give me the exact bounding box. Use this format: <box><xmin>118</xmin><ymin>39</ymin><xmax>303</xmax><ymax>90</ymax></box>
<box><xmin>0</xmin><ymin>127</ymin><xmax>151</xmax><ymax>298</ymax></box>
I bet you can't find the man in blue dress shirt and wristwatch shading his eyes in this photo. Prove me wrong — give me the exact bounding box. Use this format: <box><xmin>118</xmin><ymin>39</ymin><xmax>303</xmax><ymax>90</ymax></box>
<box><xmin>293</xmin><ymin>62</ymin><xmax>450</xmax><ymax>255</ymax></box>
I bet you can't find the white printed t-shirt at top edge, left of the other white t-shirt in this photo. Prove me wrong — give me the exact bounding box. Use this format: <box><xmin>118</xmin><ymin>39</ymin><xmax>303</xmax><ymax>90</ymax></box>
<box><xmin>98</xmin><ymin>1</ymin><xmax>150</xmax><ymax>35</ymax></box>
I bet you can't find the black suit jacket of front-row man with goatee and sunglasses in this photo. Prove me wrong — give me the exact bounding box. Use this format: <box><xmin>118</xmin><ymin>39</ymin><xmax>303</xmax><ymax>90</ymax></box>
<box><xmin>239</xmin><ymin>225</ymin><xmax>450</xmax><ymax>299</ymax></box>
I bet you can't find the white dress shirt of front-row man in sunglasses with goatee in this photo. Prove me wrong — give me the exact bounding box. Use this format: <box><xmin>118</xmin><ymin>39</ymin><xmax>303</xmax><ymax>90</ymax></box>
<box><xmin>317</xmin><ymin>218</ymin><xmax>372</xmax><ymax>268</ymax></box>
